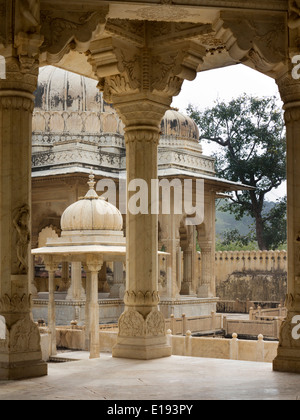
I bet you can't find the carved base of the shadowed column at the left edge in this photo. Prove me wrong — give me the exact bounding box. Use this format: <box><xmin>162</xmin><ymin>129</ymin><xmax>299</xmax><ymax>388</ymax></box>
<box><xmin>0</xmin><ymin>314</ymin><xmax>48</xmax><ymax>380</ymax></box>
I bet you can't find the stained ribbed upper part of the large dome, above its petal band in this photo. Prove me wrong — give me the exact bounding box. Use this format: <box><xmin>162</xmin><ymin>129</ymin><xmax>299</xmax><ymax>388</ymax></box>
<box><xmin>35</xmin><ymin>66</ymin><xmax>103</xmax><ymax>112</ymax></box>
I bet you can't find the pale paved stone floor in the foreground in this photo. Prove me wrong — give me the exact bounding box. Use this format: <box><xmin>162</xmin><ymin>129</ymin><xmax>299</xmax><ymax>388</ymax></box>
<box><xmin>0</xmin><ymin>352</ymin><xmax>300</xmax><ymax>401</ymax></box>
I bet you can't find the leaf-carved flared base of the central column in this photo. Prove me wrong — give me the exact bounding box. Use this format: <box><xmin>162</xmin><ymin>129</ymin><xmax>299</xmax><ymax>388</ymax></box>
<box><xmin>112</xmin><ymin>309</ymin><xmax>172</xmax><ymax>360</ymax></box>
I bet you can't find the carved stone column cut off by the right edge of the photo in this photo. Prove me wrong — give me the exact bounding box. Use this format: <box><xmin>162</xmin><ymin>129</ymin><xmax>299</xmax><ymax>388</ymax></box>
<box><xmin>273</xmin><ymin>70</ymin><xmax>300</xmax><ymax>372</ymax></box>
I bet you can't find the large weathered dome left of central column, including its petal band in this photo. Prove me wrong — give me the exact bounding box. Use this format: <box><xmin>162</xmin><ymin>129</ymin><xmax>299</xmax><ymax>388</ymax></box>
<box><xmin>32</xmin><ymin>66</ymin><xmax>124</xmax><ymax>137</ymax></box>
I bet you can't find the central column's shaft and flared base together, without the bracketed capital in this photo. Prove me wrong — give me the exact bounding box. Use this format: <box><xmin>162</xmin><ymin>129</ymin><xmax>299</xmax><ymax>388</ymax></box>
<box><xmin>113</xmin><ymin>123</ymin><xmax>171</xmax><ymax>359</ymax></box>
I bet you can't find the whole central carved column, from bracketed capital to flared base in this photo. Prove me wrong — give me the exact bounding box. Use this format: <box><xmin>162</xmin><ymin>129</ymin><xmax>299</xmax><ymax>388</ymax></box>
<box><xmin>89</xmin><ymin>20</ymin><xmax>207</xmax><ymax>359</ymax></box>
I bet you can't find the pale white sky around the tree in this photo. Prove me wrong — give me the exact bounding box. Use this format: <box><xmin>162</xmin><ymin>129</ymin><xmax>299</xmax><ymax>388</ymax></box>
<box><xmin>172</xmin><ymin>64</ymin><xmax>286</xmax><ymax>201</ymax></box>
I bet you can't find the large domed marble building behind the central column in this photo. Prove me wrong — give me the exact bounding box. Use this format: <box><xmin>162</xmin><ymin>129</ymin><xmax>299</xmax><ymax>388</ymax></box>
<box><xmin>32</xmin><ymin>66</ymin><xmax>248</xmax><ymax>332</ymax></box>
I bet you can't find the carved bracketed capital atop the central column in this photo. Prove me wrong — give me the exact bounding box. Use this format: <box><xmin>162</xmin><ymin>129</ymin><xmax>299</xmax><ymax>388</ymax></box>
<box><xmin>89</xmin><ymin>20</ymin><xmax>207</xmax><ymax>125</ymax></box>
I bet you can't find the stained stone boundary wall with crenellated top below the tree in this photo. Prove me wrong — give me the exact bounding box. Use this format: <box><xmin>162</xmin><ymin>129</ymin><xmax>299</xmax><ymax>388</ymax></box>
<box><xmin>215</xmin><ymin>251</ymin><xmax>287</xmax><ymax>302</ymax></box>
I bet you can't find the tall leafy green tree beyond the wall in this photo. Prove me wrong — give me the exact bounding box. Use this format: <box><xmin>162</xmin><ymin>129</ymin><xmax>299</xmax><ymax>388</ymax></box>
<box><xmin>188</xmin><ymin>95</ymin><xmax>286</xmax><ymax>250</ymax></box>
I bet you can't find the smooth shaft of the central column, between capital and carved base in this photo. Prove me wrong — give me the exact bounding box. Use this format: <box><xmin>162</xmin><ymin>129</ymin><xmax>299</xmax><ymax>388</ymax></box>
<box><xmin>125</xmin><ymin>130</ymin><xmax>159</xmax><ymax>316</ymax></box>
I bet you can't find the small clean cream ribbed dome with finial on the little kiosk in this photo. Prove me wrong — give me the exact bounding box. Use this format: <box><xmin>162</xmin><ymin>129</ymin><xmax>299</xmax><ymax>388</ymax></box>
<box><xmin>61</xmin><ymin>175</ymin><xmax>123</xmax><ymax>233</ymax></box>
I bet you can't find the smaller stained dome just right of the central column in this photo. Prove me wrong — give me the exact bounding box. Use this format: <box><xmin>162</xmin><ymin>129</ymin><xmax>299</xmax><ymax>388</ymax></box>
<box><xmin>161</xmin><ymin>109</ymin><xmax>199</xmax><ymax>142</ymax></box>
